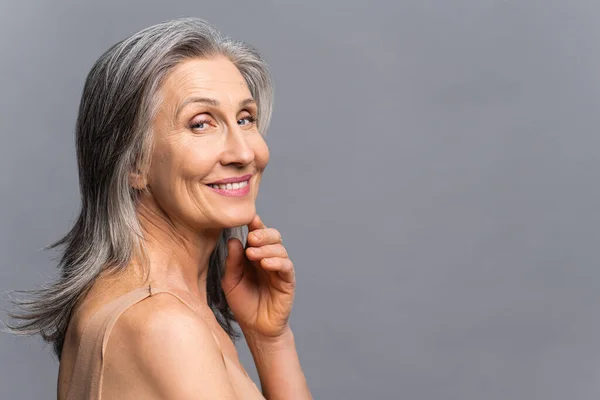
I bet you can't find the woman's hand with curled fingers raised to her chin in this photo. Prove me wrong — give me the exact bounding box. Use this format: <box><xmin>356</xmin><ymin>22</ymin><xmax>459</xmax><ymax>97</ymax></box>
<box><xmin>221</xmin><ymin>215</ymin><xmax>296</xmax><ymax>340</ymax></box>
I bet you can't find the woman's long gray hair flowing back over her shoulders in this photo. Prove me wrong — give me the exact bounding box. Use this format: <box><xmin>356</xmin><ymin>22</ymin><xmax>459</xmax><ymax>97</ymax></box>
<box><xmin>8</xmin><ymin>18</ymin><xmax>273</xmax><ymax>359</ymax></box>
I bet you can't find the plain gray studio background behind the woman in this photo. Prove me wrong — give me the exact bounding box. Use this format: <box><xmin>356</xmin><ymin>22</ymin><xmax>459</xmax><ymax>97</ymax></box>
<box><xmin>0</xmin><ymin>0</ymin><xmax>600</xmax><ymax>400</ymax></box>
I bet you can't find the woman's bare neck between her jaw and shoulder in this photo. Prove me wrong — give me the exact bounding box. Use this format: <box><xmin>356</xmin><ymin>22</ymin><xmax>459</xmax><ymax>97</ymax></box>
<box><xmin>132</xmin><ymin>194</ymin><xmax>221</xmax><ymax>301</ymax></box>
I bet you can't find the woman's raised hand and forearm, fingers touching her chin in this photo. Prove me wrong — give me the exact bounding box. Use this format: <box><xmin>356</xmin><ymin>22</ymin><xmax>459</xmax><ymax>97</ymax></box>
<box><xmin>221</xmin><ymin>215</ymin><xmax>311</xmax><ymax>400</ymax></box>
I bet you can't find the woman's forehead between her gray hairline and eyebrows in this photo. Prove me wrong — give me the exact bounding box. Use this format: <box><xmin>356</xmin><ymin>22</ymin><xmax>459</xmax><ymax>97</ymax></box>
<box><xmin>160</xmin><ymin>57</ymin><xmax>252</xmax><ymax>107</ymax></box>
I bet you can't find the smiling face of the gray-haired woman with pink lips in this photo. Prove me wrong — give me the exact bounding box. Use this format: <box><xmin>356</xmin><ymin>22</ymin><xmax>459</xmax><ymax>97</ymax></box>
<box><xmin>147</xmin><ymin>57</ymin><xmax>269</xmax><ymax>230</ymax></box>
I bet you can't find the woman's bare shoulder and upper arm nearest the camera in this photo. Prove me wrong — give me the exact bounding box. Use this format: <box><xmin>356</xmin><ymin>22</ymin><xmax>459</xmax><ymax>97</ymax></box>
<box><xmin>105</xmin><ymin>293</ymin><xmax>236</xmax><ymax>400</ymax></box>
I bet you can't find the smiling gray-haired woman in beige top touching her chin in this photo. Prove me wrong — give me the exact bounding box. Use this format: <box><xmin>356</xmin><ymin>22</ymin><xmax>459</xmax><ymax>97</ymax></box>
<box><xmin>7</xmin><ymin>18</ymin><xmax>311</xmax><ymax>400</ymax></box>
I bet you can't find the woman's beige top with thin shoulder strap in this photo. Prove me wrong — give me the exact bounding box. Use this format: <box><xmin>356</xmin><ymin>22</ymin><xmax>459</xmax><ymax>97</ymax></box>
<box><xmin>66</xmin><ymin>285</ymin><xmax>264</xmax><ymax>400</ymax></box>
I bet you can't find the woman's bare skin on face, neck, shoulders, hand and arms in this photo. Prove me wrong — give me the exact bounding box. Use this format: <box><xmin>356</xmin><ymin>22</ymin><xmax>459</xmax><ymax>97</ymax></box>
<box><xmin>59</xmin><ymin>57</ymin><xmax>312</xmax><ymax>399</ymax></box>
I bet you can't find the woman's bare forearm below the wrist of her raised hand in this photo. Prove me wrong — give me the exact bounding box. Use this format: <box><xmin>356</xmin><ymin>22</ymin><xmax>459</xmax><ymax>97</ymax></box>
<box><xmin>246</xmin><ymin>329</ymin><xmax>312</xmax><ymax>400</ymax></box>
